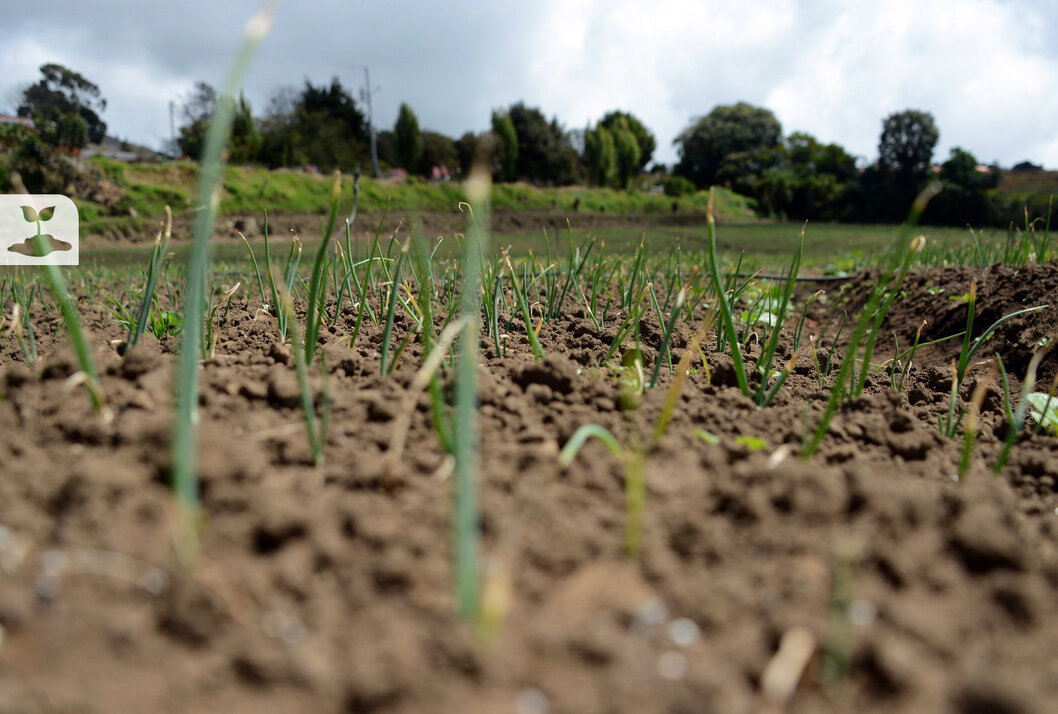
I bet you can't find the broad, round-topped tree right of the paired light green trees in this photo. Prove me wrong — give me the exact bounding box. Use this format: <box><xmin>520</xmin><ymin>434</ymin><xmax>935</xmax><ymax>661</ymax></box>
<box><xmin>673</xmin><ymin>102</ymin><xmax>783</xmax><ymax>188</ymax></box>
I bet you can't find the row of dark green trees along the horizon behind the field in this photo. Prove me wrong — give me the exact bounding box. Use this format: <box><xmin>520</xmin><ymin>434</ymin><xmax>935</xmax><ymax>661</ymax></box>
<box><xmin>6</xmin><ymin>65</ymin><xmax>1049</xmax><ymax>225</ymax></box>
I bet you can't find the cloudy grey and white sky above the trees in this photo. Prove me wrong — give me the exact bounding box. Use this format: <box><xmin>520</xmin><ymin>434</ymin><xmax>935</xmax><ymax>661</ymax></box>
<box><xmin>0</xmin><ymin>0</ymin><xmax>1058</xmax><ymax>169</ymax></box>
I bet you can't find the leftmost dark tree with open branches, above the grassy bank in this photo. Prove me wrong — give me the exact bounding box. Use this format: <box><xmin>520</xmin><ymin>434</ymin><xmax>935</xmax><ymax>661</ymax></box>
<box><xmin>17</xmin><ymin>65</ymin><xmax>107</xmax><ymax>149</ymax></box>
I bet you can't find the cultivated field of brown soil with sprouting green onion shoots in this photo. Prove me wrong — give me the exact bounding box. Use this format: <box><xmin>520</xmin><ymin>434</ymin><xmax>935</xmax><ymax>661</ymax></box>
<box><xmin>0</xmin><ymin>175</ymin><xmax>1058</xmax><ymax>714</ymax></box>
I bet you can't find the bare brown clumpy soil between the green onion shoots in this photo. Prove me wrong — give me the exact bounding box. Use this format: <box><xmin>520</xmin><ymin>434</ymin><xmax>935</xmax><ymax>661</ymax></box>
<box><xmin>0</xmin><ymin>264</ymin><xmax>1058</xmax><ymax>714</ymax></box>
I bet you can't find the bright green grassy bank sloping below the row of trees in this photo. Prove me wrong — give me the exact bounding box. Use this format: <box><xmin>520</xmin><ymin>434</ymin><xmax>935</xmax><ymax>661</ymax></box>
<box><xmin>75</xmin><ymin>158</ymin><xmax>756</xmax><ymax>239</ymax></box>
